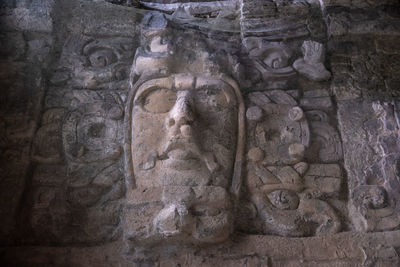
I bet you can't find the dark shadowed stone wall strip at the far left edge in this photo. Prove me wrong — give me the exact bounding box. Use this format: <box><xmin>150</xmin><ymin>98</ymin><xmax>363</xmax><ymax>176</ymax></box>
<box><xmin>0</xmin><ymin>1</ymin><xmax>54</xmax><ymax>244</ymax></box>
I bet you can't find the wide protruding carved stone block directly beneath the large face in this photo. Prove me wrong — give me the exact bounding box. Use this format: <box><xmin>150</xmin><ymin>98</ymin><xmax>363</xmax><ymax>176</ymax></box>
<box><xmin>124</xmin><ymin>186</ymin><xmax>233</xmax><ymax>247</ymax></box>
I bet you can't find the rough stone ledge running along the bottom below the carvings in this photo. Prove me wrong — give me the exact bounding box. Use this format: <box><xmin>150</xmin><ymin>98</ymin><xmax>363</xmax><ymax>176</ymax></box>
<box><xmin>1</xmin><ymin>231</ymin><xmax>399</xmax><ymax>266</ymax></box>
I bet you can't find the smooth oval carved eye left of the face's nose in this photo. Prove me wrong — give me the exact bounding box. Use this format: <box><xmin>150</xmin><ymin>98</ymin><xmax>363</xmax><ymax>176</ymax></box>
<box><xmin>142</xmin><ymin>88</ymin><xmax>176</xmax><ymax>113</ymax></box>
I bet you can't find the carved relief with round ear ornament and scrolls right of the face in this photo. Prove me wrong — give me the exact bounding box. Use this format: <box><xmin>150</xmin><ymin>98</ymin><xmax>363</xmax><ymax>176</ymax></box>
<box><xmin>246</xmin><ymin>90</ymin><xmax>346</xmax><ymax>236</ymax></box>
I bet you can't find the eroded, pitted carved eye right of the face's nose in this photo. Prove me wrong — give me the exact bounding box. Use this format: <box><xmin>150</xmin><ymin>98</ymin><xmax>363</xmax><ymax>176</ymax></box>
<box><xmin>194</xmin><ymin>88</ymin><xmax>228</xmax><ymax>111</ymax></box>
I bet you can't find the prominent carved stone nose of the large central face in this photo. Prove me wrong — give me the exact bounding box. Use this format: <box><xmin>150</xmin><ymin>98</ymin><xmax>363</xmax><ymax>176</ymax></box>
<box><xmin>167</xmin><ymin>91</ymin><xmax>195</xmax><ymax>137</ymax></box>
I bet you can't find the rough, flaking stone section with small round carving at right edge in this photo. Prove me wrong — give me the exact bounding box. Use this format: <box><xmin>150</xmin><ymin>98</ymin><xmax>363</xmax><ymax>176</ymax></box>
<box><xmin>339</xmin><ymin>101</ymin><xmax>399</xmax><ymax>231</ymax></box>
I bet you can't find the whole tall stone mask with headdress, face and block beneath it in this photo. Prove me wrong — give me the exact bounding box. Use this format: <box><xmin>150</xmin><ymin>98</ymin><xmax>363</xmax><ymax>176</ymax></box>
<box><xmin>124</xmin><ymin>14</ymin><xmax>244</xmax><ymax>247</ymax></box>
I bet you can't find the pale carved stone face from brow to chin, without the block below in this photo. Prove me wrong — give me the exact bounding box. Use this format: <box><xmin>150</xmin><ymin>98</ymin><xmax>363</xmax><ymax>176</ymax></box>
<box><xmin>132</xmin><ymin>74</ymin><xmax>237</xmax><ymax>188</ymax></box>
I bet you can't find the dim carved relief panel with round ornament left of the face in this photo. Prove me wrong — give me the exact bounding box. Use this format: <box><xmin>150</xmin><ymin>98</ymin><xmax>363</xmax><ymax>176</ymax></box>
<box><xmin>29</xmin><ymin>36</ymin><xmax>134</xmax><ymax>243</ymax></box>
